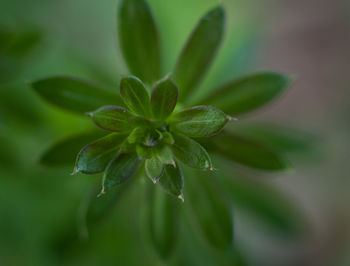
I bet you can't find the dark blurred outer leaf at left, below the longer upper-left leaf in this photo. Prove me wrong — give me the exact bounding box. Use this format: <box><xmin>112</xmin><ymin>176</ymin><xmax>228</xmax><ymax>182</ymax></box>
<box><xmin>40</xmin><ymin>132</ymin><xmax>105</xmax><ymax>167</ymax></box>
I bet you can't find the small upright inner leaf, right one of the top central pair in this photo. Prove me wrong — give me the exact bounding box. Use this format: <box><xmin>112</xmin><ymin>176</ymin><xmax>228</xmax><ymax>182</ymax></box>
<box><xmin>151</xmin><ymin>78</ymin><xmax>178</xmax><ymax>120</ymax></box>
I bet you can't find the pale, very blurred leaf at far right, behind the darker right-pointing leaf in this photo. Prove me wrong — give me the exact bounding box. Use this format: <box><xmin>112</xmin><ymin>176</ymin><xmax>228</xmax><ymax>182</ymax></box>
<box><xmin>230</xmin><ymin>123</ymin><xmax>315</xmax><ymax>154</ymax></box>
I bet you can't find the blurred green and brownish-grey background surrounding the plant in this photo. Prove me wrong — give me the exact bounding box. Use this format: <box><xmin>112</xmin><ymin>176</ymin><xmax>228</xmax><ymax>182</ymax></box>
<box><xmin>0</xmin><ymin>0</ymin><xmax>350</xmax><ymax>266</ymax></box>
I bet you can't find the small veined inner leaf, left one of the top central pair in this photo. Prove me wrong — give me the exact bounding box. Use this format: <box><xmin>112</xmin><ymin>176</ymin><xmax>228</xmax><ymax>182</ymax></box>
<box><xmin>120</xmin><ymin>76</ymin><xmax>151</xmax><ymax>117</ymax></box>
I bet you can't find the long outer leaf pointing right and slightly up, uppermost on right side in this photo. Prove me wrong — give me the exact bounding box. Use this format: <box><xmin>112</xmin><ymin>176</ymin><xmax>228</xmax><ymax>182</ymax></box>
<box><xmin>199</xmin><ymin>72</ymin><xmax>290</xmax><ymax>115</ymax></box>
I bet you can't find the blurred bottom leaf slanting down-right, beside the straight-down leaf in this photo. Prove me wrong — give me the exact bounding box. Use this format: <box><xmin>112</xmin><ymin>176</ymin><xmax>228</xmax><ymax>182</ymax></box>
<box><xmin>185</xmin><ymin>169</ymin><xmax>233</xmax><ymax>250</ymax></box>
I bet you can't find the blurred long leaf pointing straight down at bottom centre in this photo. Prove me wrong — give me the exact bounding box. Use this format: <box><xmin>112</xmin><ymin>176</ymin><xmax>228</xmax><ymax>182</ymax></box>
<box><xmin>142</xmin><ymin>181</ymin><xmax>180</xmax><ymax>260</ymax></box>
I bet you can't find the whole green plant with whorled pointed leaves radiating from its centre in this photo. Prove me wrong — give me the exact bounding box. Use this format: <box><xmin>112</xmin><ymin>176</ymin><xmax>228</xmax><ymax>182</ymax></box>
<box><xmin>31</xmin><ymin>0</ymin><xmax>310</xmax><ymax>258</ymax></box>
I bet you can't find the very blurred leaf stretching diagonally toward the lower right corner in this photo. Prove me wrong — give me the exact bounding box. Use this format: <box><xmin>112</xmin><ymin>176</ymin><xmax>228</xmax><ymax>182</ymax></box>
<box><xmin>220</xmin><ymin>165</ymin><xmax>306</xmax><ymax>237</ymax></box>
